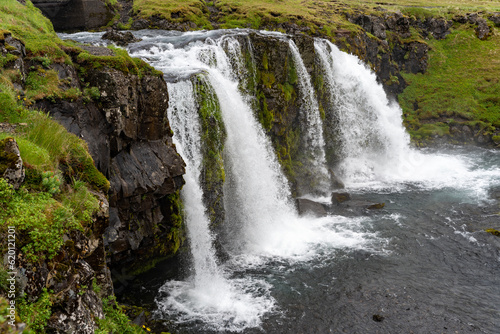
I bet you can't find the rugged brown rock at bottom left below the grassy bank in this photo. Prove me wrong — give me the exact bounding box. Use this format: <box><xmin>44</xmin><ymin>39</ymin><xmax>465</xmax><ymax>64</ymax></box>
<box><xmin>10</xmin><ymin>187</ymin><xmax>113</xmax><ymax>334</ymax></box>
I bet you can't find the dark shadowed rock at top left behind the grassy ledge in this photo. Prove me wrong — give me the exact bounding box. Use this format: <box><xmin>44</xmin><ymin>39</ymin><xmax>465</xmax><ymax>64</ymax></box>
<box><xmin>32</xmin><ymin>0</ymin><xmax>113</xmax><ymax>31</ymax></box>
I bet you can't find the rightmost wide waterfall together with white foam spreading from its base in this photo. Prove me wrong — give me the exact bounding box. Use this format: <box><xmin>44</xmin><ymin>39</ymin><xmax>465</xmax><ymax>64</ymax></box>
<box><xmin>314</xmin><ymin>39</ymin><xmax>495</xmax><ymax>196</ymax></box>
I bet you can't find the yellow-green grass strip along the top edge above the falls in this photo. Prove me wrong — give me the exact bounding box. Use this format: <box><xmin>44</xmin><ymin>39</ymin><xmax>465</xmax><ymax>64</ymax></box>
<box><xmin>133</xmin><ymin>0</ymin><xmax>500</xmax><ymax>37</ymax></box>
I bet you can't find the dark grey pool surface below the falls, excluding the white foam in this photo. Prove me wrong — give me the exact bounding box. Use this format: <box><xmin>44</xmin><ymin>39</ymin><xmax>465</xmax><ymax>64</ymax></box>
<box><xmin>122</xmin><ymin>149</ymin><xmax>500</xmax><ymax>333</ymax></box>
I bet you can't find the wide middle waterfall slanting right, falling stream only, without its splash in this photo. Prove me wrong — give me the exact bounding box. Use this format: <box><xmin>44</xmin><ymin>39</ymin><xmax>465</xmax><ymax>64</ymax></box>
<box><xmin>204</xmin><ymin>36</ymin><xmax>306</xmax><ymax>252</ymax></box>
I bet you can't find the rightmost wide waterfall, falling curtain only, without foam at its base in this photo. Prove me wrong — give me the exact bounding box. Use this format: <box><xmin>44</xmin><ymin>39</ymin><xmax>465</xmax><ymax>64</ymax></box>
<box><xmin>314</xmin><ymin>40</ymin><xmax>410</xmax><ymax>181</ymax></box>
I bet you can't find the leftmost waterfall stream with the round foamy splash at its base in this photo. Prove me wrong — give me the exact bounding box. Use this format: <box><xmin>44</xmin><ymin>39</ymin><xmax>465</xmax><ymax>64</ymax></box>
<box><xmin>158</xmin><ymin>80</ymin><xmax>273</xmax><ymax>330</ymax></box>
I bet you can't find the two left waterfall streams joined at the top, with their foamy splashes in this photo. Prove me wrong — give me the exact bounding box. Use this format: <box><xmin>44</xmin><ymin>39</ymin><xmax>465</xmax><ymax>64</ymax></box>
<box><xmin>127</xmin><ymin>32</ymin><xmax>375</xmax><ymax>331</ymax></box>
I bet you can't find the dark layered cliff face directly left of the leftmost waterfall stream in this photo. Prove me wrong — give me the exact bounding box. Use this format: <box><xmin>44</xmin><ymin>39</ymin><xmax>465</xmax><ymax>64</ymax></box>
<box><xmin>37</xmin><ymin>47</ymin><xmax>184</xmax><ymax>271</ymax></box>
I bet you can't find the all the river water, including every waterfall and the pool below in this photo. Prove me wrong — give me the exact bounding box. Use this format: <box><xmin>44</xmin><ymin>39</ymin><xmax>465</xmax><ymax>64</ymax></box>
<box><xmin>62</xmin><ymin>30</ymin><xmax>500</xmax><ymax>333</ymax></box>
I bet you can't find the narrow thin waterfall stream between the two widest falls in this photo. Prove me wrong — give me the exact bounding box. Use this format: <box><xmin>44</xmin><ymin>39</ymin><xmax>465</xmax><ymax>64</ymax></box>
<box><xmin>289</xmin><ymin>40</ymin><xmax>330</xmax><ymax>193</ymax></box>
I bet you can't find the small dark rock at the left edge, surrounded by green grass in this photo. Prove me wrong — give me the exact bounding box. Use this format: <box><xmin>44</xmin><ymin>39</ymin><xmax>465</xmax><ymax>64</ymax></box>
<box><xmin>0</xmin><ymin>137</ymin><xmax>25</xmax><ymax>189</ymax></box>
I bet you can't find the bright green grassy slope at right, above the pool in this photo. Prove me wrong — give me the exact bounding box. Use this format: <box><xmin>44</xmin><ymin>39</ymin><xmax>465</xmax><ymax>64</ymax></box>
<box><xmin>399</xmin><ymin>25</ymin><xmax>500</xmax><ymax>139</ymax></box>
